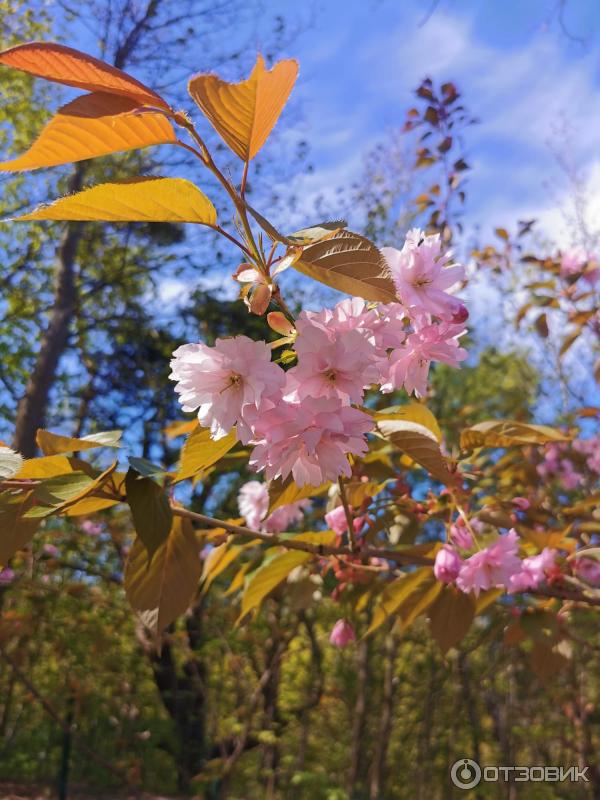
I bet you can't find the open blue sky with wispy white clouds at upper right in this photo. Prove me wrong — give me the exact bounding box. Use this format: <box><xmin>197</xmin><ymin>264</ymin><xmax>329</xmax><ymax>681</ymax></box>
<box><xmin>251</xmin><ymin>0</ymin><xmax>600</xmax><ymax>244</ymax></box>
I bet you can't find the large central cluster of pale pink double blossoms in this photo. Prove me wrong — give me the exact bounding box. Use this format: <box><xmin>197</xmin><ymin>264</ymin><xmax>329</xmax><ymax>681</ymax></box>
<box><xmin>170</xmin><ymin>230</ymin><xmax>468</xmax><ymax>486</ymax></box>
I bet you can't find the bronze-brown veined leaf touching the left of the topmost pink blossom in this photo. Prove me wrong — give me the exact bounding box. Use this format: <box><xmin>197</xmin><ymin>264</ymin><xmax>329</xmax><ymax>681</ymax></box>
<box><xmin>293</xmin><ymin>230</ymin><xmax>398</xmax><ymax>303</ymax></box>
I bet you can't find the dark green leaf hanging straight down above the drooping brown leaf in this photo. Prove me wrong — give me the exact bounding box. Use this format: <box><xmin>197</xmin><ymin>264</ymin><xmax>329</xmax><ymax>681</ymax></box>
<box><xmin>125</xmin><ymin>468</ymin><xmax>173</xmax><ymax>561</ymax></box>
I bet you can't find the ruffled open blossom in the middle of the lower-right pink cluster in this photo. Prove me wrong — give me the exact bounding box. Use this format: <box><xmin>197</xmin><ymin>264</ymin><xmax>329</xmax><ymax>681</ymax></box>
<box><xmin>456</xmin><ymin>528</ymin><xmax>521</xmax><ymax>595</ymax></box>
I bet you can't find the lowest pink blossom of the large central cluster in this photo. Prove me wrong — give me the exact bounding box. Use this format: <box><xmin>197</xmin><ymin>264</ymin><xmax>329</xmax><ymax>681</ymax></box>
<box><xmin>250</xmin><ymin>397</ymin><xmax>373</xmax><ymax>486</ymax></box>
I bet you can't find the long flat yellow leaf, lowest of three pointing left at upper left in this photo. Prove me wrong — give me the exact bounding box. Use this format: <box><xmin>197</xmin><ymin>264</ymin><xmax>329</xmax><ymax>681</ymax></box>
<box><xmin>16</xmin><ymin>177</ymin><xmax>217</xmax><ymax>225</ymax></box>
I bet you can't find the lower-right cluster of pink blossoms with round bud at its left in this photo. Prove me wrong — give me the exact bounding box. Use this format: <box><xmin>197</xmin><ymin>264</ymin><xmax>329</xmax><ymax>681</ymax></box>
<box><xmin>433</xmin><ymin>523</ymin><xmax>557</xmax><ymax>596</ymax></box>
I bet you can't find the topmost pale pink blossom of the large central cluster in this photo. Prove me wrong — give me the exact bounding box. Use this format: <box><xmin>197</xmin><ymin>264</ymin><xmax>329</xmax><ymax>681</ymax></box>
<box><xmin>382</xmin><ymin>228</ymin><xmax>465</xmax><ymax>319</ymax></box>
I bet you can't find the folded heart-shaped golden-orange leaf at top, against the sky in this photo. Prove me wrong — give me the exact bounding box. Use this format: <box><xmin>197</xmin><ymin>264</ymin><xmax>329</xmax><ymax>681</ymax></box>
<box><xmin>188</xmin><ymin>56</ymin><xmax>298</xmax><ymax>161</ymax></box>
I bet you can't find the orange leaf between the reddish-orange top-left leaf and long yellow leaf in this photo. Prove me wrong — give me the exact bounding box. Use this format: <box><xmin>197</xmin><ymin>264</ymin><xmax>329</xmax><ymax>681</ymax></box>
<box><xmin>0</xmin><ymin>92</ymin><xmax>177</xmax><ymax>172</ymax></box>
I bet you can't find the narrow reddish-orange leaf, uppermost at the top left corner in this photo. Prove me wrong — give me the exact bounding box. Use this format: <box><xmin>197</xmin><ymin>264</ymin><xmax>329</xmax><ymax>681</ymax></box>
<box><xmin>0</xmin><ymin>42</ymin><xmax>169</xmax><ymax>109</ymax></box>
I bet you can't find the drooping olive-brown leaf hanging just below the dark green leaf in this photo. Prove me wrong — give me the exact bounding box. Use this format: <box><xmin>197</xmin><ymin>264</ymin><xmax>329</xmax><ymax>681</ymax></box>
<box><xmin>124</xmin><ymin>517</ymin><xmax>202</xmax><ymax>635</ymax></box>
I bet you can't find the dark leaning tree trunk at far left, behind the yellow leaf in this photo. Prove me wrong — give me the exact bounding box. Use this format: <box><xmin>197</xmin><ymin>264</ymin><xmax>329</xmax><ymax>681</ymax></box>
<box><xmin>13</xmin><ymin>167</ymin><xmax>85</xmax><ymax>458</ymax></box>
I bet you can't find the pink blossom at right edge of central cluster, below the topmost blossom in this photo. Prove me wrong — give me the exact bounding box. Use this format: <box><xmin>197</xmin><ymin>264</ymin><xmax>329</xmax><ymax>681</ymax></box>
<box><xmin>381</xmin><ymin>322</ymin><xmax>467</xmax><ymax>397</ymax></box>
